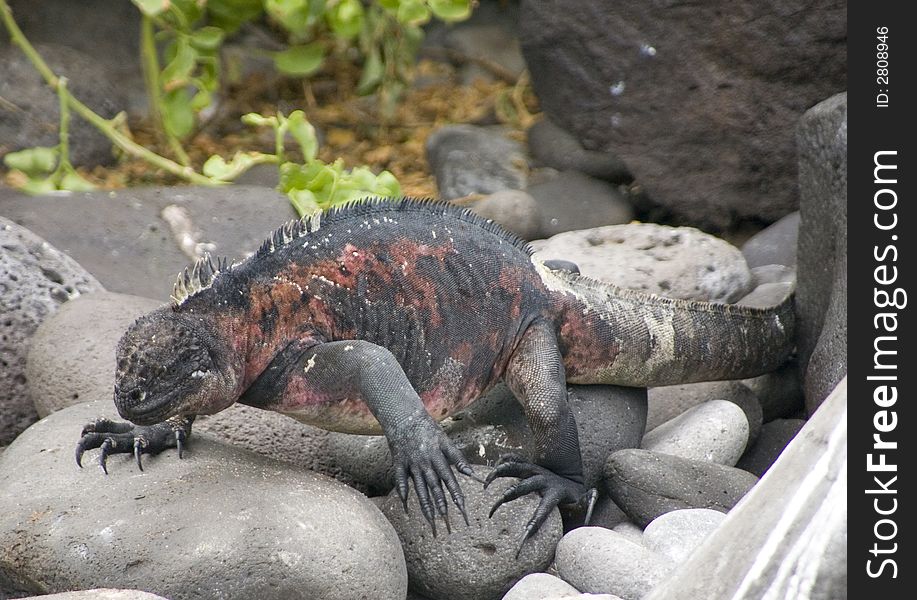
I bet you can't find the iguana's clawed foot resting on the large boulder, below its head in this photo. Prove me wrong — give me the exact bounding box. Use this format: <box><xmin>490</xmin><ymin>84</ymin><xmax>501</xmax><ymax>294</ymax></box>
<box><xmin>76</xmin><ymin>417</ymin><xmax>193</xmax><ymax>475</ymax></box>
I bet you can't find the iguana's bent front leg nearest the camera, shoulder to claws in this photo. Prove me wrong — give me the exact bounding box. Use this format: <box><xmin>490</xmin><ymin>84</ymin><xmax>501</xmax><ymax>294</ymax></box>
<box><xmin>240</xmin><ymin>340</ymin><xmax>474</xmax><ymax>533</ymax></box>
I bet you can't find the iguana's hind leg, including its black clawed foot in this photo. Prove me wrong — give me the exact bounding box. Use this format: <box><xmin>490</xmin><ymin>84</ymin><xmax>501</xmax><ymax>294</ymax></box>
<box><xmin>486</xmin><ymin>321</ymin><xmax>595</xmax><ymax>548</ymax></box>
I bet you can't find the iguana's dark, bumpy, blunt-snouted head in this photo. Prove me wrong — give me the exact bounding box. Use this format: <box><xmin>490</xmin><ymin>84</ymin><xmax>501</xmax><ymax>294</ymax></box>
<box><xmin>115</xmin><ymin>307</ymin><xmax>239</xmax><ymax>425</ymax></box>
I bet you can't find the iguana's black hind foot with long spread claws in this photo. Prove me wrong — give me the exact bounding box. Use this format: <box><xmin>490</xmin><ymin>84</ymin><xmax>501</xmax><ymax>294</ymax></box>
<box><xmin>484</xmin><ymin>454</ymin><xmax>598</xmax><ymax>558</ymax></box>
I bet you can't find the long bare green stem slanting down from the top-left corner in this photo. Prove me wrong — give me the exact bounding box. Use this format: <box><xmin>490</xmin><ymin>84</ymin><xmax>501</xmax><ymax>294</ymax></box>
<box><xmin>0</xmin><ymin>0</ymin><xmax>222</xmax><ymax>186</ymax></box>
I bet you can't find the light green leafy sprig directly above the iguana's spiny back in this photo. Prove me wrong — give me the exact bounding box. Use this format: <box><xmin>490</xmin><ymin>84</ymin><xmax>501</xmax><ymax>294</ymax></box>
<box><xmin>204</xmin><ymin>110</ymin><xmax>401</xmax><ymax>216</ymax></box>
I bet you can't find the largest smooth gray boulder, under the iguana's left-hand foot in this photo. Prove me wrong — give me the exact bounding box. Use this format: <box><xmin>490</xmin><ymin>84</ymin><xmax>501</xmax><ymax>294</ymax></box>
<box><xmin>0</xmin><ymin>402</ymin><xmax>407</xmax><ymax>600</ymax></box>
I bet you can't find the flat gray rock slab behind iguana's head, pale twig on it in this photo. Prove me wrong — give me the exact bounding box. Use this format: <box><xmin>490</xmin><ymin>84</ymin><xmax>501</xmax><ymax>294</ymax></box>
<box><xmin>0</xmin><ymin>186</ymin><xmax>296</xmax><ymax>301</ymax></box>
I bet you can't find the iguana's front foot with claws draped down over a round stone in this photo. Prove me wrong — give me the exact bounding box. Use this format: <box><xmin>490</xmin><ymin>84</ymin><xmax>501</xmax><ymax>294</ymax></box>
<box><xmin>389</xmin><ymin>418</ymin><xmax>483</xmax><ymax>537</ymax></box>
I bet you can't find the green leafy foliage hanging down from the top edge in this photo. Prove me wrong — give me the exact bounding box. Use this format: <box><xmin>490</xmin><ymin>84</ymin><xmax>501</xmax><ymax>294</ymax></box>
<box><xmin>132</xmin><ymin>0</ymin><xmax>473</xmax><ymax>146</ymax></box>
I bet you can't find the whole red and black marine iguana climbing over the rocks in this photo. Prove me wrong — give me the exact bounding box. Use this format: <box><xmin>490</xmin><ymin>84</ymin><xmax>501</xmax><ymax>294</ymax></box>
<box><xmin>76</xmin><ymin>199</ymin><xmax>793</xmax><ymax>548</ymax></box>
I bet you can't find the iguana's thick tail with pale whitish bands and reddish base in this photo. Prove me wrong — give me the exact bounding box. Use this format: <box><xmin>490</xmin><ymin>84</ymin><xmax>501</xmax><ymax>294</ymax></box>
<box><xmin>539</xmin><ymin>267</ymin><xmax>795</xmax><ymax>386</ymax></box>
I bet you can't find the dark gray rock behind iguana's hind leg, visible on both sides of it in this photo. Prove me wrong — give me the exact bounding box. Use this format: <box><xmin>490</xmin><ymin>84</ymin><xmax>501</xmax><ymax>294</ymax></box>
<box><xmin>446</xmin><ymin>385</ymin><xmax>646</xmax><ymax>486</ymax></box>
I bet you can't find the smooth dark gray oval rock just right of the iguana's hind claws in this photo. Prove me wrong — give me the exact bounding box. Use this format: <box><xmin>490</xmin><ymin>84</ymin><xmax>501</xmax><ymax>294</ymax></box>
<box><xmin>605</xmin><ymin>450</ymin><xmax>758</xmax><ymax>527</ymax></box>
